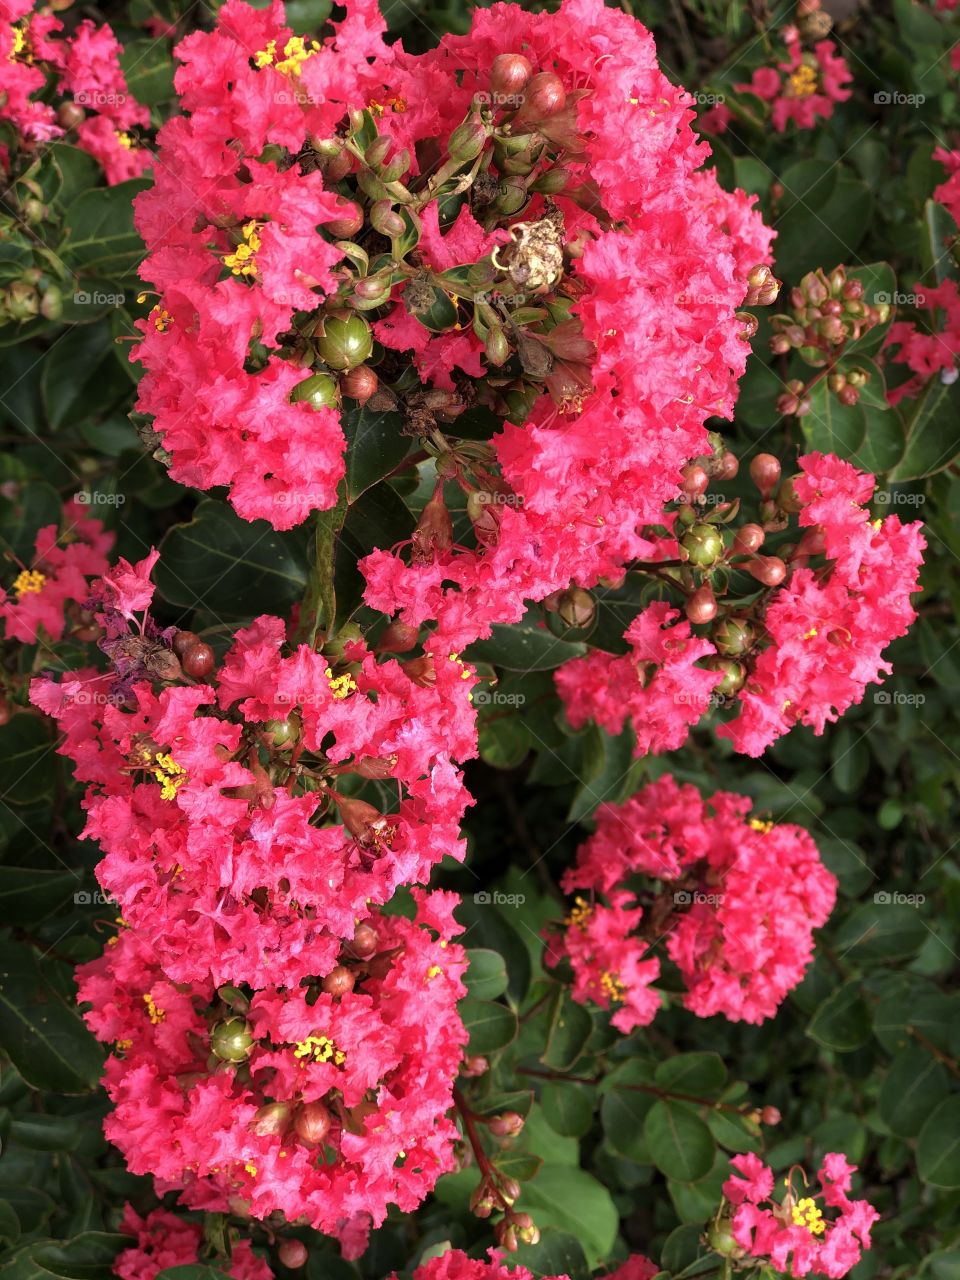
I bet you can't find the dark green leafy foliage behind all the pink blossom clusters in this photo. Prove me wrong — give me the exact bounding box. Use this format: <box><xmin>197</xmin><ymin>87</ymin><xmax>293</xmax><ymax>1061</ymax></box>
<box><xmin>0</xmin><ymin>0</ymin><xmax>960</xmax><ymax>1280</ymax></box>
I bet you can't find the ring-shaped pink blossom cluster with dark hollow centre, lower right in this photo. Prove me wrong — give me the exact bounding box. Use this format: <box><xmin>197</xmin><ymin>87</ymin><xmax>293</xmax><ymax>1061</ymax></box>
<box><xmin>547</xmin><ymin>774</ymin><xmax>836</xmax><ymax>1032</ymax></box>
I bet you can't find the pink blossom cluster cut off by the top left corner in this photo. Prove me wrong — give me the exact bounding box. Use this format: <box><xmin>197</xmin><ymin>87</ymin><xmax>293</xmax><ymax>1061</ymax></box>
<box><xmin>0</xmin><ymin>0</ymin><xmax>152</xmax><ymax>183</ymax></box>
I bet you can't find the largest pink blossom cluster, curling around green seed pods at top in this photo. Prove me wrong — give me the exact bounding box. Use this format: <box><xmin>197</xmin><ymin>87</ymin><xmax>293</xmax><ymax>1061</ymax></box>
<box><xmin>134</xmin><ymin>0</ymin><xmax>777</xmax><ymax>627</ymax></box>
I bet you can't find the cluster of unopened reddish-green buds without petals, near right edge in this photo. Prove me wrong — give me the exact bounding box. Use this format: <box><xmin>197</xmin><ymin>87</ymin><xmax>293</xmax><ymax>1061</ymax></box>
<box><xmin>771</xmin><ymin>266</ymin><xmax>890</xmax><ymax>417</ymax></box>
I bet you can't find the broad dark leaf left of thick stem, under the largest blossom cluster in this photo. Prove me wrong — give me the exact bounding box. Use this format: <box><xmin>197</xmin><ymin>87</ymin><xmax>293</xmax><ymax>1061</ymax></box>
<box><xmin>154</xmin><ymin>498</ymin><xmax>307</xmax><ymax>621</ymax></box>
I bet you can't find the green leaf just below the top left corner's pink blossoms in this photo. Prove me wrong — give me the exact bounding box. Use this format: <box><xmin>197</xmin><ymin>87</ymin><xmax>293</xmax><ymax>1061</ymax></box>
<box><xmin>60</xmin><ymin>178</ymin><xmax>150</xmax><ymax>282</ymax></box>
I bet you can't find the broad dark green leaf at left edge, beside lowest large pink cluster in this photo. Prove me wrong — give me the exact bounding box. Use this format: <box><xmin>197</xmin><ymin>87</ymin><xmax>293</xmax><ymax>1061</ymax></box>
<box><xmin>0</xmin><ymin>940</ymin><xmax>104</xmax><ymax>1093</ymax></box>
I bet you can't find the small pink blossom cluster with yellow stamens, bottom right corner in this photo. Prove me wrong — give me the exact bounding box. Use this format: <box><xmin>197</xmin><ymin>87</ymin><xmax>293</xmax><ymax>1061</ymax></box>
<box><xmin>708</xmin><ymin>1152</ymin><xmax>879</xmax><ymax>1280</ymax></box>
